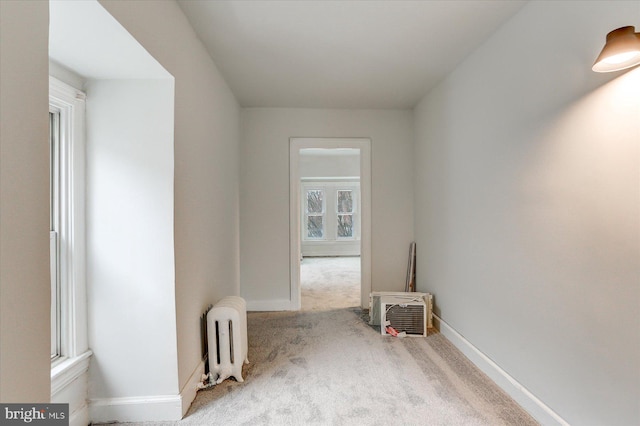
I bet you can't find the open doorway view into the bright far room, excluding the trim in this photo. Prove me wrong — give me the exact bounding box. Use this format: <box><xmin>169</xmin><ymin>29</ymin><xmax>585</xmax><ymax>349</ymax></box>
<box><xmin>298</xmin><ymin>148</ymin><xmax>361</xmax><ymax>311</ymax></box>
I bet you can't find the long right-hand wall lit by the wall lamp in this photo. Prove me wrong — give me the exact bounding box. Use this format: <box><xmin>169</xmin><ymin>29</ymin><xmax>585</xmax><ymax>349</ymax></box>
<box><xmin>414</xmin><ymin>1</ymin><xmax>640</xmax><ymax>425</ymax></box>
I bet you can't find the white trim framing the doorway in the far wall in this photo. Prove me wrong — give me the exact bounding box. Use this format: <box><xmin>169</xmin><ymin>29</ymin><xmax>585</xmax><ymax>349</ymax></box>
<box><xmin>289</xmin><ymin>138</ymin><xmax>371</xmax><ymax>311</ymax></box>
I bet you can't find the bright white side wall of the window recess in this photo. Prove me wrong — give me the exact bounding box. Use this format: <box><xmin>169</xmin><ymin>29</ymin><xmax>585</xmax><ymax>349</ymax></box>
<box><xmin>86</xmin><ymin>80</ymin><xmax>178</xmax><ymax>406</ymax></box>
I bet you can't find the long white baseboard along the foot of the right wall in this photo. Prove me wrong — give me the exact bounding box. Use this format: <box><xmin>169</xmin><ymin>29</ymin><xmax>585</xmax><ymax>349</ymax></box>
<box><xmin>433</xmin><ymin>314</ymin><xmax>569</xmax><ymax>426</ymax></box>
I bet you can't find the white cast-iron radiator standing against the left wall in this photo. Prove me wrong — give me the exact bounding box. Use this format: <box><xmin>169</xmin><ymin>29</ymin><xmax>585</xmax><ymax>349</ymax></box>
<box><xmin>207</xmin><ymin>296</ymin><xmax>249</xmax><ymax>384</ymax></box>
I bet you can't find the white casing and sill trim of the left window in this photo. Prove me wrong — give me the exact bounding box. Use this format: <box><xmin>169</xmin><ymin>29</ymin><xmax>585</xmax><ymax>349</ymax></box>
<box><xmin>49</xmin><ymin>77</ymin><xmax>92</xmax><ymax>426</ymax></box>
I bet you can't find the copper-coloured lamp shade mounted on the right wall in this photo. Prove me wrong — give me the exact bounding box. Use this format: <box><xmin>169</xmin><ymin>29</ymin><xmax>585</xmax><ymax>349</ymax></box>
<box><xmin>591</xmin><ymin>27</ymin><xmax>640</xmax><ymax>72</ymax></box>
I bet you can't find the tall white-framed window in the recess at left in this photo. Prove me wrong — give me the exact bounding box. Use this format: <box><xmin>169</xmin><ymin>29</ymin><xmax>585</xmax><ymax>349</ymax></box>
<box><xmin>49</xmin><ymin>78</ymin><xmax>86</xmax><ymax>366</ymax></box>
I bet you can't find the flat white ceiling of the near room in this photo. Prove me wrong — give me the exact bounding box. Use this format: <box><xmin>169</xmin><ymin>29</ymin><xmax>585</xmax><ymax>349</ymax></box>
<box><xmin>178</xmin><ymin>0</ymin><xmax>525</xmax><ymax>108</ymax></box>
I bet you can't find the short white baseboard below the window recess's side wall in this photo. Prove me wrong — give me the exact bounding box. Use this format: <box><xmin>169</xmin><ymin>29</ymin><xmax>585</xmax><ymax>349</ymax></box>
<box><xmin>89</xmin><ymin>395</ymin><xmax>182</xmax><ymax>423</ymax></box>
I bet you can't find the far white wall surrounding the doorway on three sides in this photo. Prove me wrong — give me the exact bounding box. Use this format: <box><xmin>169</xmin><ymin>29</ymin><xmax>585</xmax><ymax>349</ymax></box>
<box><xmin>240</xmin><ymin>108</ymin><xmax>413</xmax><ymax>306</ymax></box>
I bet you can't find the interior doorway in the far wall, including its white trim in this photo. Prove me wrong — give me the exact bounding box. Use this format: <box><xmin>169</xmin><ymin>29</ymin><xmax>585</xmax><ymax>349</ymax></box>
<box><xmin>290</xmin><ymin>138</ymin><xmax>371</xmax><ymax>310</ymax></box>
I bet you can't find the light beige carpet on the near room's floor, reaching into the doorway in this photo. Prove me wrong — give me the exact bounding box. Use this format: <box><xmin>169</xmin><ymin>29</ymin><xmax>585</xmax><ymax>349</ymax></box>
<box><xmin>102</xmin><ymin>256</ymin><xmax>537</xmax><ymax>426</ymax></box>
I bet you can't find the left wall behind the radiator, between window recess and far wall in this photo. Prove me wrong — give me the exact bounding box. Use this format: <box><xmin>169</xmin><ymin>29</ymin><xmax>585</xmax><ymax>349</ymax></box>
<box><xmin>100</xmin><ymin>0</ymin><xmax>239</xmax><ymax>410</ymax></box>
